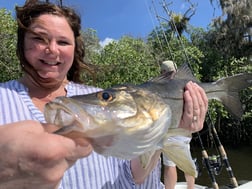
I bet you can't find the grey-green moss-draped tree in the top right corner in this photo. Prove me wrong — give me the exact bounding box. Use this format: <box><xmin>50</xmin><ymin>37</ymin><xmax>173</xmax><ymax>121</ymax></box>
<box><xmin>208</xmin><ymin>0</ymin><xmax>252</xmax><ymax>58</ymax></box>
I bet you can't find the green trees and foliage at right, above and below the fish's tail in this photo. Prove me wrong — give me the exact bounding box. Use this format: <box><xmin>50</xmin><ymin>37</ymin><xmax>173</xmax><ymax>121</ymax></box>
<box><xmin>148</xmin><ymin>1</ymin><xmax>252</xmax><ymax>143</ymax></box>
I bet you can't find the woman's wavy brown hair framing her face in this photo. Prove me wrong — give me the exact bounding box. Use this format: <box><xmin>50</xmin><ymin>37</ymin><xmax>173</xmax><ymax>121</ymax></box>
<box><xmin>16</xmin><ymin>0</ymin><xmax>90</xmax><ymax>82</ymax></box>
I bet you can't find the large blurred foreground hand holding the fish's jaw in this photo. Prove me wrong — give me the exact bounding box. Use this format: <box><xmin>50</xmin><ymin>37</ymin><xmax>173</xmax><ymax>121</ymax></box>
<box><xmin>0</xmin><ymin>121</ymin><xmax>92</xmax><ymax>189</ymax></box>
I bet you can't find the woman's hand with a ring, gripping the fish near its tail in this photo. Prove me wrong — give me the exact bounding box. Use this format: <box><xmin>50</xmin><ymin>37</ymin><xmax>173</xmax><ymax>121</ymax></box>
<box><xmin>179</xmin><ymin>81</ymin><xmax>208</xmax><ymax>132</ymax></box>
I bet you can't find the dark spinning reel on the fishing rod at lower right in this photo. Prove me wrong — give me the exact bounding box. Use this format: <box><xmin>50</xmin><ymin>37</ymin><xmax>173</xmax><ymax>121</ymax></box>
<box><xmin>202</xmin><ymin>155</ymin><xmax>222</xmax><ymax>175</ymax></box>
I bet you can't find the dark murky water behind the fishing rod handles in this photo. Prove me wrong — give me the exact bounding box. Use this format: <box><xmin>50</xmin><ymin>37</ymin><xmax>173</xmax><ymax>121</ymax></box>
<box><xmin>178</xmin><ymin>146</ymin><xmax>252</xmax><ymax>187</ymax></box>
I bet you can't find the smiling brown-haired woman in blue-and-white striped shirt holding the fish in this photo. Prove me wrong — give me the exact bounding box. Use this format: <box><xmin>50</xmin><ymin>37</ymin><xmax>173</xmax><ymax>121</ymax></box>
<box><xmin>0</xmin><ymin>1</ymin><xmax>207</xmax><ymax>189</ymax></box>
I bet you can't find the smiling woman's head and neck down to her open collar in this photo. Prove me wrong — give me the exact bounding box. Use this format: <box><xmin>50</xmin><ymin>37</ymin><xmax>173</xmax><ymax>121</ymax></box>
<box><xmin>17</xmin><ymin>3</ymin><xmax>80</xmax><ymax>111</ymax></box>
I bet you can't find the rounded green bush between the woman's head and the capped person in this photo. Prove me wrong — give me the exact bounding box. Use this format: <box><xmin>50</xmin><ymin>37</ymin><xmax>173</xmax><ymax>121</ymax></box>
<box><xmin>85</xmin><ymin>36</ymin><xmax>159</xmax><ymax>88</ymax></box>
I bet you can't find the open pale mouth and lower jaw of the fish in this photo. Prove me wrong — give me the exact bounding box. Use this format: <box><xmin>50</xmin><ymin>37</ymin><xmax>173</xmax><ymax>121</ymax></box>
<box><xmin>44</xmin><ymin>97</ymin><xmax>118</xmax><ymax>153</ymax></box>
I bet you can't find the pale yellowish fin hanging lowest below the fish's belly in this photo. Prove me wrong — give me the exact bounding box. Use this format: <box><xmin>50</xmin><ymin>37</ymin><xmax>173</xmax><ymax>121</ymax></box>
<box><xmin>162</xmin><ymin>139</ymin><xmax>198</xmax><ymax>177</ymax></box>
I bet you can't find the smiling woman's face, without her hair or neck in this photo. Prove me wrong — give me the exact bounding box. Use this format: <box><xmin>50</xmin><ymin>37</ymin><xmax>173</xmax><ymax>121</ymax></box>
<box><xmin>24</xmin><ymin>14</ymin><xmax>75</xmax><ymax>81</ymax></box>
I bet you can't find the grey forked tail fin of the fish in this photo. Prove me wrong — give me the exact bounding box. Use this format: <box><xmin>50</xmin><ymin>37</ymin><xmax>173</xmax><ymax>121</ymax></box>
<box><xmin>207</xmin><ymin>73</ymin><xmax>252</xmax><ymax>118</ymax></box>
